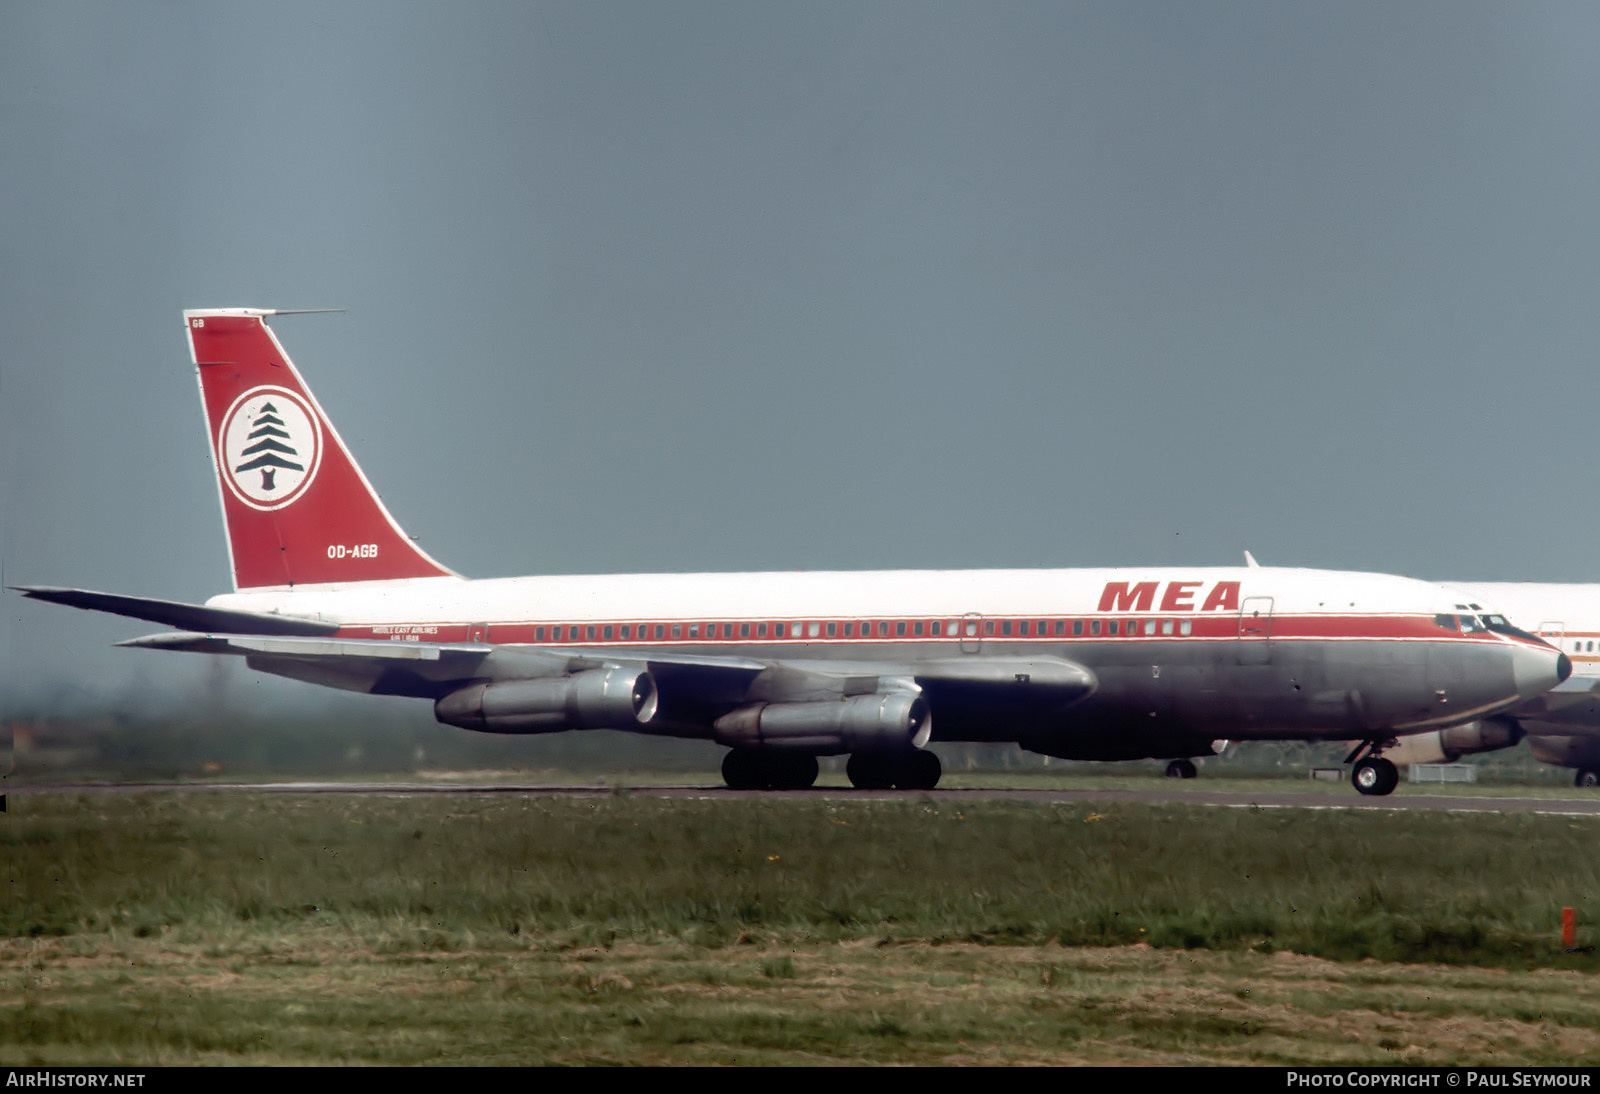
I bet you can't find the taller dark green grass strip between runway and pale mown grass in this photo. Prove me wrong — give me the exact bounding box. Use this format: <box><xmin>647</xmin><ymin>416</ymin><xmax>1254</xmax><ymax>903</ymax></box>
<box><xmin>0</xmin><ymin>793</ymin><xmax>1600</xmax><ymax>968</ymax></box>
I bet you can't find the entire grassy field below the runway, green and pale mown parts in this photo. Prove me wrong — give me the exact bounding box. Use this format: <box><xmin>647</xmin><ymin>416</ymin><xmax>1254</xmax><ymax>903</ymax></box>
<box><xmin>0</xmin><ymin>781</ymin><xmax>1600</xmax><ymax>1064</ymax></box>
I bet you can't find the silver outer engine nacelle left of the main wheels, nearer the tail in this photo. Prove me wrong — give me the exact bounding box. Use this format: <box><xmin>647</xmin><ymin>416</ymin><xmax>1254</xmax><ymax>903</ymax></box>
<box><xmin>434</xmin><ymin>665</ymin><xmax>658</xmax><ymax>733</ymax></box>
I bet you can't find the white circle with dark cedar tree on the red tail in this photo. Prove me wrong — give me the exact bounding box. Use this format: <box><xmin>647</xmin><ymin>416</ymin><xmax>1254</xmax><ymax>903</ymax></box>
<box><xmin>216</xmin><ymin>387</ymin><xmax>322</xmax><ymax>510</ymax></box>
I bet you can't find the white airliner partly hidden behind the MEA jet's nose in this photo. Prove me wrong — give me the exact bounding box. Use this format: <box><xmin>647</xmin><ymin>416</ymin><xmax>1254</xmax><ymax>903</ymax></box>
<box><xmin>1390</xmin><ymin>582</ymin><xmax>1600</xmax><ymax>787</ymax></box>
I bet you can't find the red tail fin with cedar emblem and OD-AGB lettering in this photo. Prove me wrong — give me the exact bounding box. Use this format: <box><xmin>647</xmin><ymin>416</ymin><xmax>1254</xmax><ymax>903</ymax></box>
<box><xmin>184</xmin><ymin>307</ymin><xmax>451</xmax><ymax>589</ymax></box>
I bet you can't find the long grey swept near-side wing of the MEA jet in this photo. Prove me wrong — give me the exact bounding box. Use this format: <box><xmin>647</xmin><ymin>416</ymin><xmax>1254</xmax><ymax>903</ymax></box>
<box><xmin>118</xmin><ymin>632</ymin><xmax>1098</xmax><ymax>737</ymax></box>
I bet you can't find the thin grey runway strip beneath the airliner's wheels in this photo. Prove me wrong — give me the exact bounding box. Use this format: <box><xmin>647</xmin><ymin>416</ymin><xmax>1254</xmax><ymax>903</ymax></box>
<box><xmin>12</xmin><ymin>782</ymin><xmax>1600</xmax><ymax>817</ymax></box>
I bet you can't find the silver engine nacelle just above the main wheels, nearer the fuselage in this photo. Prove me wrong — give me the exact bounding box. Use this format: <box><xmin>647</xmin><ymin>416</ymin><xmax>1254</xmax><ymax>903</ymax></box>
<box><xmin>714</xmin><ymin>691</ymin><xmax>933</xmax><ymax>755</ymax></box>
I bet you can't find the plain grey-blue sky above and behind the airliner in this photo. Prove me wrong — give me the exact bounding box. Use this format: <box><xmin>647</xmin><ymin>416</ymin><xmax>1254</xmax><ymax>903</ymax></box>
<box><xmin>0</xmin><ymin>0</ymin><xmax>1600</xmax><ymax>689</ymax></box>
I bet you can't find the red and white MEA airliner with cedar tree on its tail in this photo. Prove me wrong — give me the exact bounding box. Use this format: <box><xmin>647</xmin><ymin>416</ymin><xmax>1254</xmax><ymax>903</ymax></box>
<box><xmin>3</xmin><ymin>307</ymin><xmax>1571</xmax><ymax>795</ymax></box>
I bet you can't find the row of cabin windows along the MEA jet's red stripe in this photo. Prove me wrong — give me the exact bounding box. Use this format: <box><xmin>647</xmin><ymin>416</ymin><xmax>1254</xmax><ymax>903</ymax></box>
<box><xmin>533</xmin><ymin>619</ymin><xmax>1194</xmax><ymax>641</ymax></box>
